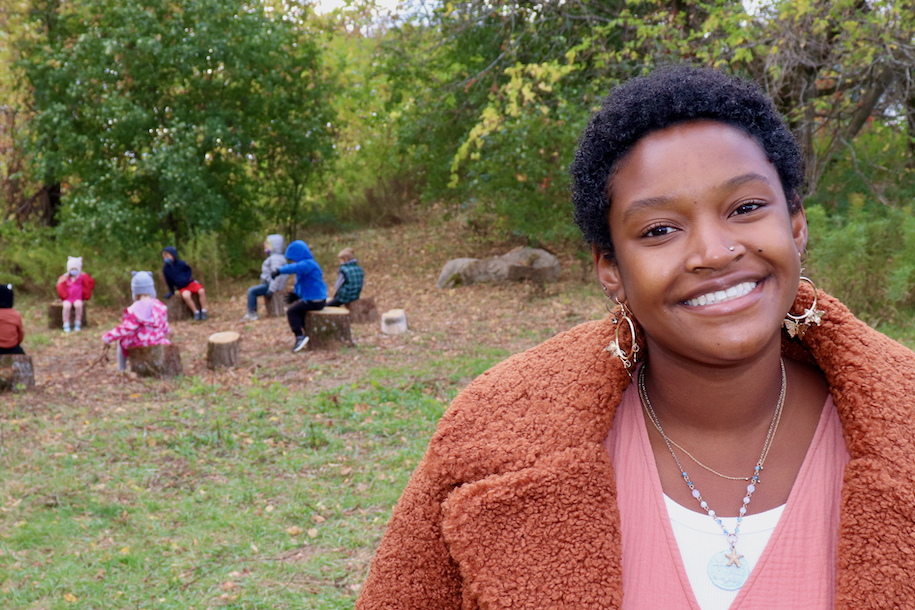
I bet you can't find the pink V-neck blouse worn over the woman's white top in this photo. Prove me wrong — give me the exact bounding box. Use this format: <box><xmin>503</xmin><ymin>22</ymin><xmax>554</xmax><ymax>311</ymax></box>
<box><xmin>604</xmin><ymin>384</ymin><xmax>849</xmax><ymax>610</ymax></box>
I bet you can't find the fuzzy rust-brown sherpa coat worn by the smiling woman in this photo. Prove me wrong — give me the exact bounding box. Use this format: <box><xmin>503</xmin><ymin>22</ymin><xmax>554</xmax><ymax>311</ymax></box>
<box><xmin>356</xmin><ymin>285</ymin><xmax>915</xmax><ymax>610</ymax></box>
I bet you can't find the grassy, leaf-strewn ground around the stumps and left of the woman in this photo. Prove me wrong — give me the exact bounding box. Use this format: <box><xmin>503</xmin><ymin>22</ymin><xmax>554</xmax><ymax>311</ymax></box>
<box><xmin>0</xmin><ymin>218</ymin><xmax>603</xmax><ymax>610</ymax></box>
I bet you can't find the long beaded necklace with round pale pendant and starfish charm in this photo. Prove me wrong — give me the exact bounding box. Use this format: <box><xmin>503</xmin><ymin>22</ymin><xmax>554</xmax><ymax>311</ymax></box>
<box><xmin>638</xmin><ymin>359</ymin><xmax>788</xmax><ymax>591</ymax></box>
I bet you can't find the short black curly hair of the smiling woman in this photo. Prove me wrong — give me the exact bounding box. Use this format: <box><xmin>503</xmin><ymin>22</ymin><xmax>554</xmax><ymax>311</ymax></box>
<box><xmin>569</xmin><ymin>64</ymin><xmax>804</xmax><ymax>260</ymax></box>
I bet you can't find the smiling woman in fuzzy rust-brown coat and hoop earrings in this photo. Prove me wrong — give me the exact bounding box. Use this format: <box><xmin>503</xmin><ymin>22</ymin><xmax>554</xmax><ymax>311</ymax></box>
<box><xmin>357</xmin><ymin>66</ymin><xmax>915</xmax><ymax>610</ymax></box>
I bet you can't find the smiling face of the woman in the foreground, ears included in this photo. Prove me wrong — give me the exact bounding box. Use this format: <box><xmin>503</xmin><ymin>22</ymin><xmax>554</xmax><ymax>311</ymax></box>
<box><xmin>595</xmin><ymin>121</ymin><xmax>807</xmax><ymax>364</ymax></box>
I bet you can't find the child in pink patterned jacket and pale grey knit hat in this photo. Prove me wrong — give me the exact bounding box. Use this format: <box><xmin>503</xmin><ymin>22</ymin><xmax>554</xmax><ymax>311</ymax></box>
<box><xmin>102</xmin><ymin>271</ymin><xmax>171</xmax><ymax>372</ymax></box>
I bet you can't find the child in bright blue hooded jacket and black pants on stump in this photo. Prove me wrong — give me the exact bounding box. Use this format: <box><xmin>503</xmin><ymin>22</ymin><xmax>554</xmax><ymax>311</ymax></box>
<box><xmin>270</xmin><ymin>239</ymin><xmax>327</xmax><ymax>353</ymax></box>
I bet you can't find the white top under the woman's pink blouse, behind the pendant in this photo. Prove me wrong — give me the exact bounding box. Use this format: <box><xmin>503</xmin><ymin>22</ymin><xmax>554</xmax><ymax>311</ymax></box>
<box><xmin>664</xmin><ymin>494</ymin><xmax>785</xmax><ymax>610</ymax></box>
